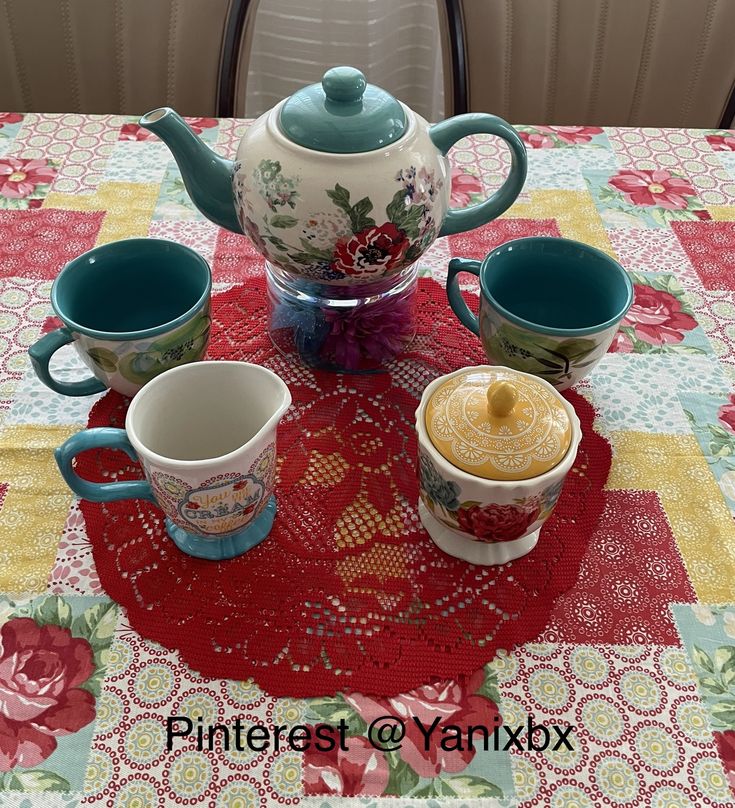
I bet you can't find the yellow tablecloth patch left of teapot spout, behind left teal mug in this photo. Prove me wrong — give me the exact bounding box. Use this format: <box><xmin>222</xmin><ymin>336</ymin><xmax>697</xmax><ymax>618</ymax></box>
<box><xmin>43</xmin><ymin>182</ymin><xmax>160</xmax><ymax>244</ymax></box>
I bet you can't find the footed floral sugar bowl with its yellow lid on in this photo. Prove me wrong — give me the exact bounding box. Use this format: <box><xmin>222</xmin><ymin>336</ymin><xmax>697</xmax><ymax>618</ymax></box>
<box><xmin>416</xmin><ymin>365</ymin><xmax>582</xmax><ymax>564</ymax></box>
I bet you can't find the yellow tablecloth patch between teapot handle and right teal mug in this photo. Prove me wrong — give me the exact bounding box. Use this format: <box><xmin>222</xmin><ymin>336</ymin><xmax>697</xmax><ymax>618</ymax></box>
<box><xmin>503</xmin><ymin>190</ymin><xmax>617</xmax><ymax>258</ymax></box>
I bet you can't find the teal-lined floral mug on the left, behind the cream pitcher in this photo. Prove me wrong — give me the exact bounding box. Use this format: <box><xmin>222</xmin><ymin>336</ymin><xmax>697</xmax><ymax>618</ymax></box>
<box><xmin>28</xmin><ymin>238</ymin><xmax>212</xmax><ymax>396</ymax></box>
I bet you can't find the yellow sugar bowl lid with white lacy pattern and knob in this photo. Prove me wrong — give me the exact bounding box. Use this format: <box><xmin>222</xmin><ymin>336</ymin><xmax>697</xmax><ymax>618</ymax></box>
<box><xmin>425</xmin><ymin>366</ymin><xmax>572</xmax><ymax>480</ymax></box>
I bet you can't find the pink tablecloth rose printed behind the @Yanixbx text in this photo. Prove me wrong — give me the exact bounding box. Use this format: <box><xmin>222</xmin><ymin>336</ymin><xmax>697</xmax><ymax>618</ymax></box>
<box><xmin>345</xmin><ymin>670</ymin><xmax>501</xmax><ymax>778</ymax></box>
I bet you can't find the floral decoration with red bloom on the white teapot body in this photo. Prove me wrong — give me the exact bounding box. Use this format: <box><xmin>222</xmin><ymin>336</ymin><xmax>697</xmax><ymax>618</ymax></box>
<box><xmin>233</xmin><ymin>160</ymin><xmax>444</xmax><ymax>284</ymax></box>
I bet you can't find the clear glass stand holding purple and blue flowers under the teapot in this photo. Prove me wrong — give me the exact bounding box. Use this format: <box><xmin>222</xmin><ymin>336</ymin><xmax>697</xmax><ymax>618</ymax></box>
<box><xmin>265</xmin><ymin>261</ymin><xmax>418</xmax><ymax>373</ymax></box>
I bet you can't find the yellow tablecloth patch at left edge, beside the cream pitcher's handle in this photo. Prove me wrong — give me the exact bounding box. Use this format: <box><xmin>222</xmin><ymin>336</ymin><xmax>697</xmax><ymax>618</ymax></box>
<box><xmin>0</xmin><ymin>425</ymin><xmax>79</xmax><ymax>592</ymax></box>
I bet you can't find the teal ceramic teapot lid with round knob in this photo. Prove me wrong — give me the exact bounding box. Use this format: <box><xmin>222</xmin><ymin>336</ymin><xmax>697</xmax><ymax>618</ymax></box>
<box><xmin>279</xmin><ymin>67</ymin><xmax>407</xmax><ymax>154</ymax></box>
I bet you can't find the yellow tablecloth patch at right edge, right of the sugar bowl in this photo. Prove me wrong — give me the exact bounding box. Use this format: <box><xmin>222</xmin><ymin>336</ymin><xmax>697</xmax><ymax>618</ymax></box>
<box><xmin>607</xmin><ymin>432</ymin><xmax>735</xmax><ymax>603</ymax></box>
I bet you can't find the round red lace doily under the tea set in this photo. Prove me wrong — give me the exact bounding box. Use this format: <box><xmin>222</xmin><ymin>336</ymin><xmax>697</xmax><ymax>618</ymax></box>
<box><xmin>78</xmin><ymin>279</ymin><xmax>611</xmax><ymax>696</ymax></box>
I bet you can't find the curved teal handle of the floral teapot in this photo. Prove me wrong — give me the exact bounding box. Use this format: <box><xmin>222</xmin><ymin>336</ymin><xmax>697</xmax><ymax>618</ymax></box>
<box><xmin>429</xmin><ymin>112</ymin><xmax>528</xmax><ymax>236</ymax></box>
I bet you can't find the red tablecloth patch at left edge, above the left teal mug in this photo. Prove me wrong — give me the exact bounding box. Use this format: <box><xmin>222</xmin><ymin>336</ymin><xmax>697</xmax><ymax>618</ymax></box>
<box><xmin>0</xmin><ymin>208</ymin><xmax>105</xmax><ymax>281</ymax></box>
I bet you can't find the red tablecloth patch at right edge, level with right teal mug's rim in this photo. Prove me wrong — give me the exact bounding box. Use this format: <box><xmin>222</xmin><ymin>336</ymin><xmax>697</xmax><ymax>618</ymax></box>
<box><xmin>671</xmin><ymin>222</ymin><xmax>735</xmax><ymax>289</ymax></box>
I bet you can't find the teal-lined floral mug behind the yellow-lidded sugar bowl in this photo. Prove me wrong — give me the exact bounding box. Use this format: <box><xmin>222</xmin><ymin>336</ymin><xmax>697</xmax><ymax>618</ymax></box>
<box><xmin>447</xmin><ymin>237</ymin><xmax>633</xmax><ymax>390</ymax></box>
